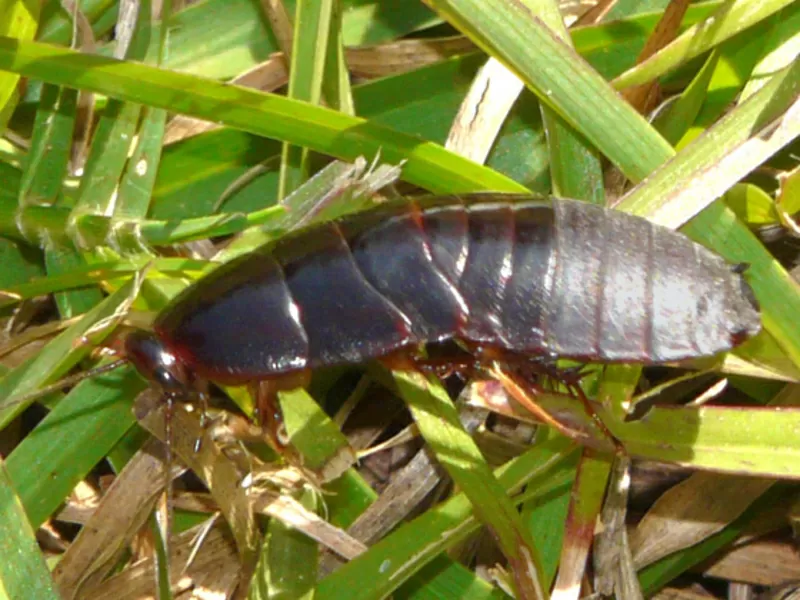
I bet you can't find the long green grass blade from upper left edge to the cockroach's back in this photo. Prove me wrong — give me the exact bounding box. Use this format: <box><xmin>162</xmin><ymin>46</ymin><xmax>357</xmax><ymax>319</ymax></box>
<box><xmin>0</xmin><ymin>38</ymin><xmax>525</xmax><ymax>193</ymax></box>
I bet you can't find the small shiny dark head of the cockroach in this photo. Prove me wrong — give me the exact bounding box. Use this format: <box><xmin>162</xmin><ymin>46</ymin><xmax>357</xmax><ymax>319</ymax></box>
<box><xmin>125</xmin><ymin>330</ymin><xmax>190</xmax><ymax>397</ymax></box>
